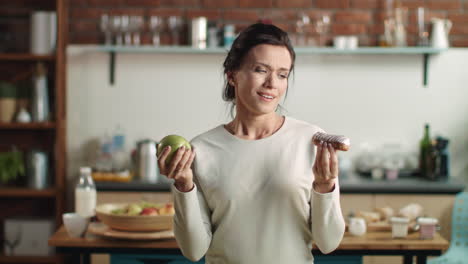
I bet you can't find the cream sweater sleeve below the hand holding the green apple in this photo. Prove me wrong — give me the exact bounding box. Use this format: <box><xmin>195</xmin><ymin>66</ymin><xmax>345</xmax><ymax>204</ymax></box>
<box><xmin>172</xmin><ymin>177</ymin><xmax>212</xmax><ymax>261</ymax></box>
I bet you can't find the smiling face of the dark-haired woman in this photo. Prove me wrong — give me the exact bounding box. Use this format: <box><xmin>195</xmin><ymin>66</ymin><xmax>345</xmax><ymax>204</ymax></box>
<box><xmin>230</xmin><ymin>44</ymin><xmax>292</xmax><ymax>115</ymax></box>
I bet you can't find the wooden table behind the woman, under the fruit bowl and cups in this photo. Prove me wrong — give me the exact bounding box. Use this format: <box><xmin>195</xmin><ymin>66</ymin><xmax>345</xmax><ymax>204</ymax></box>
<box><xmin>49</xmin><ymin>226</ymin><xmax>449</xmax><ymax>264</ymax></box>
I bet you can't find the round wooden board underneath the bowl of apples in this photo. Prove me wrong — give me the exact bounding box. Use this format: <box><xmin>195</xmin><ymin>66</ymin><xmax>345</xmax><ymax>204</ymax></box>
<box><xmin>88</xmin><ymin>223</ymin><xmax>174</xmax><ymax>240</ymax></box>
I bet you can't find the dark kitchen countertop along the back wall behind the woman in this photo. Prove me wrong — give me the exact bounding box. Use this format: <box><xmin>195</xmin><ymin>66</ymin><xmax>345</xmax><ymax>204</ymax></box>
<box><xmin>96</xmin><ymin>174</ymin><xmax>465</xmax><ymax>194</ymax></box>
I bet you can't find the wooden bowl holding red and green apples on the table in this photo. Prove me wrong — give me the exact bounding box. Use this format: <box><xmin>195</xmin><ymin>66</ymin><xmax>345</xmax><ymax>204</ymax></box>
<box><xmin>96</xmin><ymin>203</ymin><xmax>173</xmax><ymax>232</ymax></box>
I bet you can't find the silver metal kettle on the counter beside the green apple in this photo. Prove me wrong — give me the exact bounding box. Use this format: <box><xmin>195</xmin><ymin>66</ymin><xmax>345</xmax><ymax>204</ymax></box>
<box><xmin>135</xmin><ymin>139</ymin><xmax>159</xmax><ymax>183</ymax></box>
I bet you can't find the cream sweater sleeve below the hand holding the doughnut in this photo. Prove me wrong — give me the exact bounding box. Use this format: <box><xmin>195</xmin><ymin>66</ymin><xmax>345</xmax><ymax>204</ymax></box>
<box><xmin>310</xmin><ymin>181</ymin><xmax>345</xmax><ymax>254</ymax></box>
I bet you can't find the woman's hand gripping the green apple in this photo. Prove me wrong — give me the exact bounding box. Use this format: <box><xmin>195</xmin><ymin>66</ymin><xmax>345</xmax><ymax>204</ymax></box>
<box><xmin>158</xmin><ymin>146</ymin><xmax>195</xmax><ymax>192</ymax></box>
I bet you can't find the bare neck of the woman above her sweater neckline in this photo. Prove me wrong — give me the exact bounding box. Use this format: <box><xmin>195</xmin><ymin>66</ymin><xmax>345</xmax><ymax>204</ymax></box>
<box><xmin>225</xmin><ymin>113</ymin><xmax>284</xmax><ymax>140</ymax></box>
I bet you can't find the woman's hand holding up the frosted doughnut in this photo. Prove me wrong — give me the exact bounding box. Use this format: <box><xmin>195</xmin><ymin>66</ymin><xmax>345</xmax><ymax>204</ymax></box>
<box><xmin>312</xmin><ymin>142</ymin><xmax>338</xmax><ymax>193</ymax></box>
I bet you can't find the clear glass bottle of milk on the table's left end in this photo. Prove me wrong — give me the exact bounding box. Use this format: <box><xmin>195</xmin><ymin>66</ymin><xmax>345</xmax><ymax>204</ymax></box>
<box><xmin>75</xmin><ymin>167</ymin><xmax>96</xmax><ymax>217</ymax></box>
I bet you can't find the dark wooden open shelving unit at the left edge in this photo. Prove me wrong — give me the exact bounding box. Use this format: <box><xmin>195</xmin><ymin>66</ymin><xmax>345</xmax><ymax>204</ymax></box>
<box><xmin>0</xmin><ymin>0</ymin><xmax>68</xmax><ymax>263</ymax></box>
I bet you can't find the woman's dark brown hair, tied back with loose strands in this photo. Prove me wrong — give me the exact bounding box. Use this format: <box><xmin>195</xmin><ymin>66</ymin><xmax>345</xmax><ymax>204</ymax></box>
<box><xmin>223</xmin><ymin>23</ymin><xmax>296</xmax><ymax>110</ymax></box>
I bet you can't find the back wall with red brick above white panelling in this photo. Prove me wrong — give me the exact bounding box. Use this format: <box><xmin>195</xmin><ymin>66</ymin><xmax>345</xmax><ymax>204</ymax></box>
<box><xmin>61</xmin><ymin>0</ymin><xmax>468</xmax><ymax>188</ymax></box>
